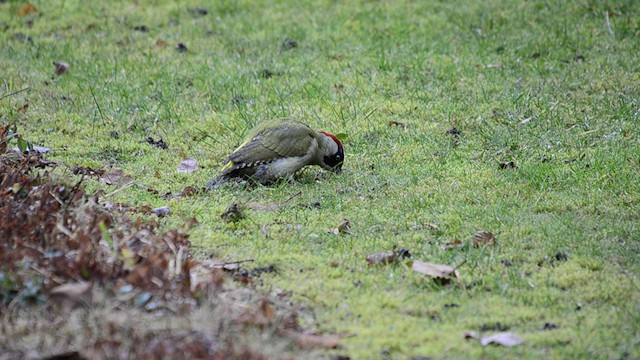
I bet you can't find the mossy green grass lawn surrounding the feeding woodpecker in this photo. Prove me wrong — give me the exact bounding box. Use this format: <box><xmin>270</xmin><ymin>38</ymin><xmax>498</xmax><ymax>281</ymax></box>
<box><xmin>0</xmin><ymin>0</ymin><xmax>640</xmax><ymax>359</ymax></box>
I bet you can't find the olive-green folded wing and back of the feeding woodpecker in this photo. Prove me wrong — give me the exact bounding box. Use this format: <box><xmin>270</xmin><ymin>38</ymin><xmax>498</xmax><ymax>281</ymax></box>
<box><xmin>223</xmin><ymin>120</ymin><xmax>316</xmax><ymax>173</ymax></box>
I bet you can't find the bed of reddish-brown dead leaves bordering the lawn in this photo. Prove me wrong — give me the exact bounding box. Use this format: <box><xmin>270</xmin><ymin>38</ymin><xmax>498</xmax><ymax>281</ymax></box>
<box><xmin>0</xmin><ymin>126</ymin><xmax>340</xmax><ymax>359</ymax></box>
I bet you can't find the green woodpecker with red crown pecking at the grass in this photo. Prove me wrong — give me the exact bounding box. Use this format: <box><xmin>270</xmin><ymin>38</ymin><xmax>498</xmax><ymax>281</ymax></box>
<box><xmin>207</xmin><ymin>119</ymin><xmax>344</xmax><ymax>187</ymax></box>
